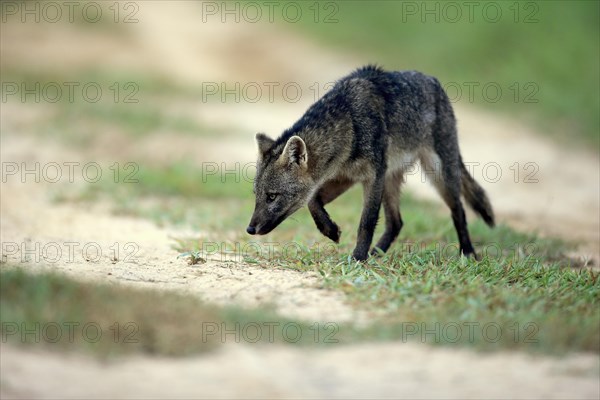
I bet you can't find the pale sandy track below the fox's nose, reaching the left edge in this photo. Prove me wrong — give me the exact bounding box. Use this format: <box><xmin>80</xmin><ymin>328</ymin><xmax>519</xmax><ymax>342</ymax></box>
<box><xmin>0</xmin><ymin>138</ymin><xmax>357</xmax><ymax>321</ymax></box>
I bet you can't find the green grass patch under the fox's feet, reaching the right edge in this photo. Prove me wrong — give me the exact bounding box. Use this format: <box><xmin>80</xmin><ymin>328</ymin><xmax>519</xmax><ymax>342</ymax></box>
<box><xmin>172</xmin><ymin>234</ymin><xmax>600</xmax><ymax>354</ymax></box>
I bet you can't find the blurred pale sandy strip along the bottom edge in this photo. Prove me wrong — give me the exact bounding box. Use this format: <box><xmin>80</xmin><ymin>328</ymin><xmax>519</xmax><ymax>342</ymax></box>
<box><xmin>0</xmin><ymin>343</ymin><xmax>599</xmax><ymax>399</ymax></box>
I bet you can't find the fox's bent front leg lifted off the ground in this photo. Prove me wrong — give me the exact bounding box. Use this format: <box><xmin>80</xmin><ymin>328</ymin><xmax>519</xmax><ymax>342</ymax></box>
<box><xmin>308</xmin><ymin>179</ymin><xmax>354</xmax><ymax>243</ymax></box>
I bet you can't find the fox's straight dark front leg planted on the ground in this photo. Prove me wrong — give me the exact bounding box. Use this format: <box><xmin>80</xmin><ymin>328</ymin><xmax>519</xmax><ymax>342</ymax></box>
<box><xmin>352</xmin><ymin>172</ymin><xmax>385</xmax><ymax>261</ymax></box>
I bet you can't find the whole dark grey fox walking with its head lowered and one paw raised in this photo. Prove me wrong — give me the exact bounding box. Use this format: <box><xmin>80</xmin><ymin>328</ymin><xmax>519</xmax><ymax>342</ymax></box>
<box><xmin>246</xmin><ymin>66</ymin><xmax>494</xmax><ymax>260</ymax></box>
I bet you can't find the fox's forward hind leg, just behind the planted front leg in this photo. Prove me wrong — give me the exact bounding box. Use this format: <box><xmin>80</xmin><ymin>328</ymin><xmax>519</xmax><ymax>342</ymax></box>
<box><xmin>371</xmin><ymin>172</ymin><xmax>403</xmax><ymax>255</ymax></box>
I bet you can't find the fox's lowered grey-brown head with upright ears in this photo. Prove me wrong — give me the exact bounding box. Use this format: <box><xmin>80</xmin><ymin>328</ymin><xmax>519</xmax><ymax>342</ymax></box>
<box><xmin>246</xmin><ymin>133</ymin><xmax>314</xmax><ymax>235</ymax></box>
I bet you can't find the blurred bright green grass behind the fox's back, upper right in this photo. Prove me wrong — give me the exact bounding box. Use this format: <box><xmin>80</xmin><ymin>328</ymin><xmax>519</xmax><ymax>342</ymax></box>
<box><xmin>285</xmin><ymin>0</ymin><xmax>600</xmax><ymax>148</ymax></box>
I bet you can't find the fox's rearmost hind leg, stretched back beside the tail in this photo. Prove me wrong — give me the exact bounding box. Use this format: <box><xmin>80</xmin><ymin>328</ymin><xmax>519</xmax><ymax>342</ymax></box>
<box><xmin>420</xmin><ymin>151</ymin><xmax>477</xmax><ymax>259</ymax></box>
